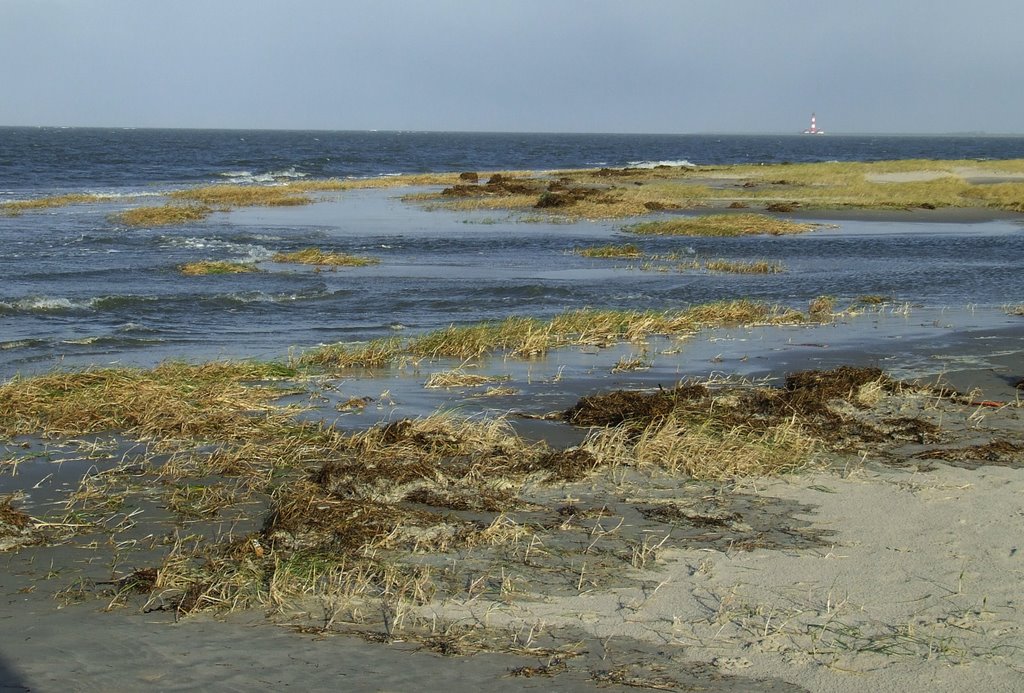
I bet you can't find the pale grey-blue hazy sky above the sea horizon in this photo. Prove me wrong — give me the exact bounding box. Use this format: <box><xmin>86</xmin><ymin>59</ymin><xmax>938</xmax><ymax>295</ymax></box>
<box><xmin>0</xmin><ymin>0</ymin><xmax>1024</xmax><ymax>134</ymax></box>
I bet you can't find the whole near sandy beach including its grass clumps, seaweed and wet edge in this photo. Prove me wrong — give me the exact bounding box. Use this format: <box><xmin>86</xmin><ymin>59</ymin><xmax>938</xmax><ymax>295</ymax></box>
<box><xmin>0</xmin><ymin>161</ymin><xmax>1024</xmax><ymax>692</ymax></box>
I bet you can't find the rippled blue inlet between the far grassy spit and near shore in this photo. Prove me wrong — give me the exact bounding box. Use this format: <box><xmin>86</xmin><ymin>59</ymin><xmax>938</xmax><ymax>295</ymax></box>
<box><xmin>0</xmin><ymin>184</ymin><xmax>1024</xmax><ymax>377</ymax></box>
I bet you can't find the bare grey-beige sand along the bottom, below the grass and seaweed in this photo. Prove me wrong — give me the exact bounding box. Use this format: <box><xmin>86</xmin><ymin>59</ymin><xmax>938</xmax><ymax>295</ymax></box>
<box><xmin>0</xmin><ymin>309</ymin><xmax>1024</xmax><ymax>691</ymax></box>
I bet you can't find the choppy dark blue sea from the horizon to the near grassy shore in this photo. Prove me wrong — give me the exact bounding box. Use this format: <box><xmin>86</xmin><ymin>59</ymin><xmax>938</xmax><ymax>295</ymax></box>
<box><xmin>0</xmin><ymin>127</ymin><xmax>1024</xmax><ymax>380</ymax></box>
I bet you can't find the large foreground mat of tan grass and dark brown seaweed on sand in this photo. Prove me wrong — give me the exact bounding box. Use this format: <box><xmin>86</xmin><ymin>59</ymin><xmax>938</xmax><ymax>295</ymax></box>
<box><xmin>149</xmin><ymin>371</ymin><xmax>879</xmax><ymax>618</ymax></box>
